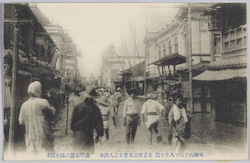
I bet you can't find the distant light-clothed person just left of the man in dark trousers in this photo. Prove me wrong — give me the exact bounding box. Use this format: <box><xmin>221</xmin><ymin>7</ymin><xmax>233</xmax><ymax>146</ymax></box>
<box><xmin>111</xmin><ymin>87</ymin><xmax>122</xmax><ymax>126</ymax></box>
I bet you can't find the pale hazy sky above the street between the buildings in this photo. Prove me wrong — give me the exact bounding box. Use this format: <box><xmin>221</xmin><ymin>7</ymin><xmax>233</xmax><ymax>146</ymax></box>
<box><xmin>37</xmin><ymin>3</ymin><xmax>178</xmax><ymax>77</ymax></box>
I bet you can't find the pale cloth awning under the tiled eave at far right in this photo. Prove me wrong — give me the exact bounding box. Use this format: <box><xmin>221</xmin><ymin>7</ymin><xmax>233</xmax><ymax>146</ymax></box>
<box><xmin>193</xmin><ymin>69</ymin><xmax>247</xmax><ymax>81</ymax></box>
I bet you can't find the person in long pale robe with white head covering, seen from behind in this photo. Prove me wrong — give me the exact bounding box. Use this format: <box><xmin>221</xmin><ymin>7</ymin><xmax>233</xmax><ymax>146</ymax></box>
<box><xmin>19</xmin><ymin>81</ymin><xmax>56</xmax><ymax>154</ymax></box>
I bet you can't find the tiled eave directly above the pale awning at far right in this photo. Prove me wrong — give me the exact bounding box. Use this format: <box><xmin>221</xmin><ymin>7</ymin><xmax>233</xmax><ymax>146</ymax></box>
<box><xmin>208</xmin><ymin>55</ymin><xmax>247</xmax><ymax>69</ymax></box>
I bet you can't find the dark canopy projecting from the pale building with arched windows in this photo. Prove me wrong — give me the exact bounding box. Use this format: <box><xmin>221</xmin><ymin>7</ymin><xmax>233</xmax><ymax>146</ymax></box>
<box><xmin>148</xmin><ymin>53</ymin><xmax>186</xmax><ymax>66</ymax></box>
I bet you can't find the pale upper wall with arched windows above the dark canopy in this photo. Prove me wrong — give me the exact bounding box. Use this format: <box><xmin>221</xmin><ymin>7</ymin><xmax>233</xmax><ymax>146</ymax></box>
<box><xmin>146</xmin><ymin>10</ymin><xmax>211</xmax><ymax>77</ymax></box>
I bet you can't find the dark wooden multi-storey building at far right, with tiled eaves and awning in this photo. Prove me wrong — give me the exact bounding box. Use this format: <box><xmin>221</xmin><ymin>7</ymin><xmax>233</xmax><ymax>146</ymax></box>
<box><xmin>194</xmin><ymin>3</ymin><xmax>247</xmax><ymax>126</ymax></box>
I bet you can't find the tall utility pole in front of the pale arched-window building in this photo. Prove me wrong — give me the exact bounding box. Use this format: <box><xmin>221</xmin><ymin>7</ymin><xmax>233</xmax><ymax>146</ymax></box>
<box><xmin>187</xmin><ymin>3</ymin><xmax>194</xmax><ymax>113</ymax></box>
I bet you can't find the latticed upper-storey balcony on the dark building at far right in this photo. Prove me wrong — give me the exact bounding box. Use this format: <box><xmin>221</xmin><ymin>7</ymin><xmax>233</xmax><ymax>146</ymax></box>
<box><xmin>223</xmin><ymin>25</ymin><xmax>247</xmax><ymax>53</ymax></box>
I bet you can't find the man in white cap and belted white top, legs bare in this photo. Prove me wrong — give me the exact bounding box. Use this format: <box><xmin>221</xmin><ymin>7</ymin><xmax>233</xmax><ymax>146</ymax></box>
<box><xmin>141</xmin><ymin>93</ymin><xmax>165</xmax><ymax>145</ymax></box>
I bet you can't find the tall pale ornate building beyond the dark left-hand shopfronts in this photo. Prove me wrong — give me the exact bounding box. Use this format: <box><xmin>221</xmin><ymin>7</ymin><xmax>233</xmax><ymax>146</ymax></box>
<box><xmin>44</xmin><ymin>24</ymin><xmax>81</xmax><ymax>90</ymax></box>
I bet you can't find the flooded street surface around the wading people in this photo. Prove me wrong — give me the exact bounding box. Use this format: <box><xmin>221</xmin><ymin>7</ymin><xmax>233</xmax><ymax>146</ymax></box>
<box><xmin>51</xmin><ymin>96</ymin><xmax>247</xmax><ymax>159</ymax></box>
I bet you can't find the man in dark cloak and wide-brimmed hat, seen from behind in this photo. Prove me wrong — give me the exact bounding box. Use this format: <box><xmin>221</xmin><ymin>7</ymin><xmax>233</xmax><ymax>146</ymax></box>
<box><xmin>71</xmin><ymin>86</ymin><xmax>103</xmax><ymax>154</ymax></box>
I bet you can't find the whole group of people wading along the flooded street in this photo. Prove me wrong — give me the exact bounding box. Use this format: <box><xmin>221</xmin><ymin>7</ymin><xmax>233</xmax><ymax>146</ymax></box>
<box><xmin>19</xmin><ymin>81</ymin><xmax>190</xmax><ymax>157</ymax></box>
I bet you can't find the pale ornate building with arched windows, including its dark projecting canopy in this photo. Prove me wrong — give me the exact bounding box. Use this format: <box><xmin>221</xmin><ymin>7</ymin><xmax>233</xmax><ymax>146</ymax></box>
<box><xmin>144</xmin><ymin>4</ymin><xmax>211</xmax><ymax>111</ymax></box>
